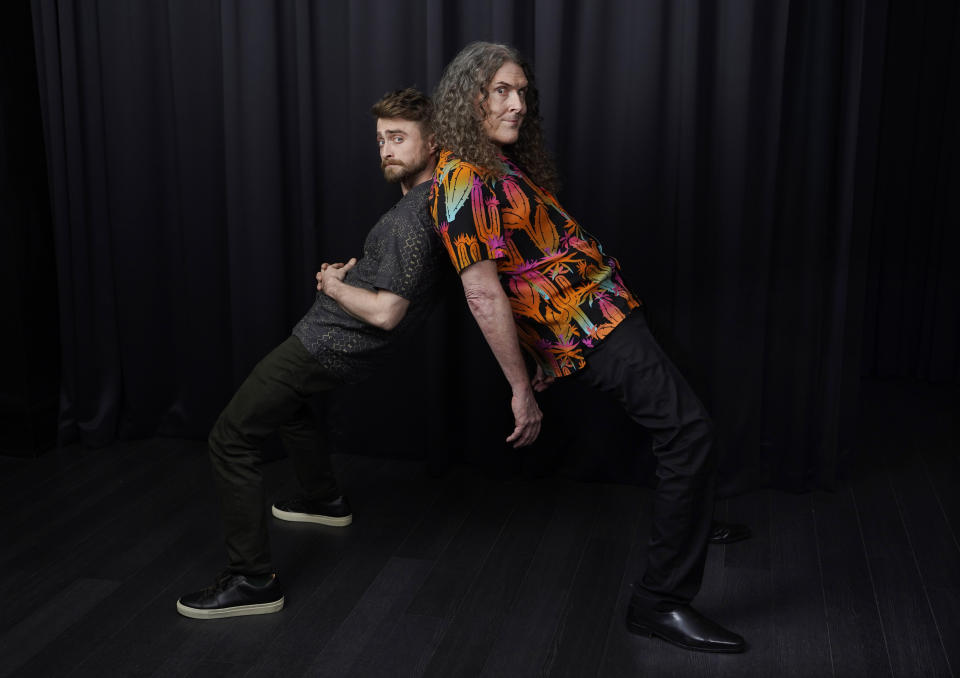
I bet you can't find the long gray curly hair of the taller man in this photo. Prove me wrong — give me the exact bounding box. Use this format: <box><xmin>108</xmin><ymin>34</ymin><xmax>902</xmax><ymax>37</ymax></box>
<box><xmin>433</xmin><ymin>42</ymin><xmax>559</xmax><ymax>193</ymax></box>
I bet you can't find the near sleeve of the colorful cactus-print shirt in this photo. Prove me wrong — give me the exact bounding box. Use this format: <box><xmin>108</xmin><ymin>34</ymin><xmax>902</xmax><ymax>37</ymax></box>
<box><xmin>431</xmin><ymin>161</ymin><xmax>507</xmax><ymax>273</ymax></box>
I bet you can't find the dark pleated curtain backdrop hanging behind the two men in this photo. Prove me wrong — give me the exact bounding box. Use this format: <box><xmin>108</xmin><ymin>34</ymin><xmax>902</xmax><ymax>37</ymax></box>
<box><xmin>5</xmin><ymin>0</ymin><xmax>960</xmax><ymax>492</ymax></box>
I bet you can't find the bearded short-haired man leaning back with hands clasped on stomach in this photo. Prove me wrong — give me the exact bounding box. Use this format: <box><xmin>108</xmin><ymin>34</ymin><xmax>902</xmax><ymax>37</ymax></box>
<box><xmin>177</xmin><ymin>89</ymin><xmax>443</xmax><ymax>619</ymax></box>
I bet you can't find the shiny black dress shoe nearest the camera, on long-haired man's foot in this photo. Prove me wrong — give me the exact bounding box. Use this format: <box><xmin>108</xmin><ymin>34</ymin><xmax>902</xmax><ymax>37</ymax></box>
<box><xmin>627</xmin><ymin>599</ymin><xmax>747</xmax><ymax>652</ymax></box>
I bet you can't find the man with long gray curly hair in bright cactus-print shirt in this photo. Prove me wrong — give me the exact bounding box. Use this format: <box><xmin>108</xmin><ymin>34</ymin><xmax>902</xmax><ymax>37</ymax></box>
<box><xmin>430</xmin><ymin>42</ymin><xmax>749</xmax><ymax>652</ymax></box>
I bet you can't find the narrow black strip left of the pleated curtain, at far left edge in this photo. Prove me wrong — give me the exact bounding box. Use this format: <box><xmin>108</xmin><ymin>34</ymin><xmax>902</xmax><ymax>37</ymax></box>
<box><xmin>0</xmin><ymin>3</ymin><xmax>60</xmax><ymax>456</ymax></box>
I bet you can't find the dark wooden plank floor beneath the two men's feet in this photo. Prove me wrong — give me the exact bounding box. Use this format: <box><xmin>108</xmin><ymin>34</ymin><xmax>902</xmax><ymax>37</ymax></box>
<box><xmin>0</xmin><ymin>382</ymin><xmax>960</xmax><ymax>678</ymax></box>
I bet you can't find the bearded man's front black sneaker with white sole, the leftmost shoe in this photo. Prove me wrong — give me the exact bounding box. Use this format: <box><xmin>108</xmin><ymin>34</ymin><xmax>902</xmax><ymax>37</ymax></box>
<box><xmin>177</xmin><ymin>571</ymin><xmax>283</xmax><ymax>619</ymax></box>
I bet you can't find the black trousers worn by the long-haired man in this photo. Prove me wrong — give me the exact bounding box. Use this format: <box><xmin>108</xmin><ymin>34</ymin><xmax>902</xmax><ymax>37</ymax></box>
<box><xmin>577</xmin><ymin>311</ymin><xmax>715</xmax><ymax>603</ymax></box>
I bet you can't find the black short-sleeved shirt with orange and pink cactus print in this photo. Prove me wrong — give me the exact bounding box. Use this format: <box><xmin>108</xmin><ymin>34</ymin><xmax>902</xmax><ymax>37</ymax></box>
<box><xmin>429</xmin><ymin>151</ymin><xmax>640</xmax><ymax>376</ymax></box>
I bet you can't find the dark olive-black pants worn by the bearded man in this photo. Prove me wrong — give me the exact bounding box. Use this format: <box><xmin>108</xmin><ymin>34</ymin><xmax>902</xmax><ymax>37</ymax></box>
<box><xmin>209</xmin><ymin>336</ymin><xmax>341</xmax><ymax>575</ymax></box>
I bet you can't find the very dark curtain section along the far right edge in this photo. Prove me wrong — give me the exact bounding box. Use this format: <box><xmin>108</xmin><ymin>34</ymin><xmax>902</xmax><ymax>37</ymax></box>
<box><xmin>863</xmin><ymin>2</ymin><xmax>960</xmax><ymax>384</ymax></box>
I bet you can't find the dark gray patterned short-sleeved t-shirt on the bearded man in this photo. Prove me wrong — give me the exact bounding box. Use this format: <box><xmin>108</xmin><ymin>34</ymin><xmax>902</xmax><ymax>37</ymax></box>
<box><xmin>293</xmin><ymin>181</ymin><xmax>446</xmax><ymax>382</ymax></box>
